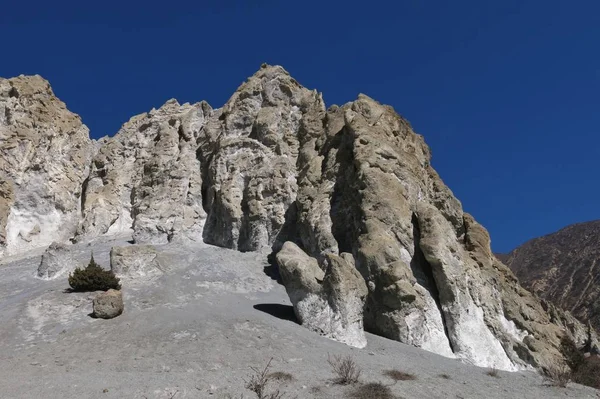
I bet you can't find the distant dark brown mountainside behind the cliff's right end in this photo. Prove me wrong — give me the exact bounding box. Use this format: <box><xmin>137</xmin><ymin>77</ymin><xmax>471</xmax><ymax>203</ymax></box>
<box><xmin>504</xmin><ymin>220</ymin><xmax>600</xmax><ymax>329</ymax></box>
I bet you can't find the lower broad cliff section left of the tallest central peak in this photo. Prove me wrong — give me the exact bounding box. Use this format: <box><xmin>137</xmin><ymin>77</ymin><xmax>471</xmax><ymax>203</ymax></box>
<box><xmin>78</xmin><ymin>100</ymin><xmax>212</xmax><ymax>244</ymax></box>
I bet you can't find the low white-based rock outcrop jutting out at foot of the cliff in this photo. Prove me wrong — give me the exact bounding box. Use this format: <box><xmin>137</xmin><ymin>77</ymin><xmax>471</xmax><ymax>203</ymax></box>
<box><xmin>277</xmin><ymin>242</ymin><xmax>368</xmax><ymax>348</ymax></box>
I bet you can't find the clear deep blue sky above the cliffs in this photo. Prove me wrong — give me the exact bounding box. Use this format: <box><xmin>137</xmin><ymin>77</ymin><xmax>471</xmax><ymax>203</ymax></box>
<box><xmin>0</xmin><ymin>0</ymin><xmax>600</xmax><ymax>251</ymax></box>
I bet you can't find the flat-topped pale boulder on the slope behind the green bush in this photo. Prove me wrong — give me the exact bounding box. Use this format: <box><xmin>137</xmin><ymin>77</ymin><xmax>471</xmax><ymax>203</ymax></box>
<box><xmin>110</xmin><ymin>245</ymin><xmax>162</xmax><ymax>277</ymax></box>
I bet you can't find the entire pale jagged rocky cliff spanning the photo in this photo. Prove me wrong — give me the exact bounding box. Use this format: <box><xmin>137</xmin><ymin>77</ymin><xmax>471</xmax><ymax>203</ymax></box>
<box><xmin>0</xmin><ymin>65</ymin><xmax>589</xmax><ymax>370</ymax></box>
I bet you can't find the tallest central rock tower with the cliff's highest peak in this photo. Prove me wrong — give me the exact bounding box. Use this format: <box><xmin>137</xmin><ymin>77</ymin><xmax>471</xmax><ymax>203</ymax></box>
<box><xmin>202</xmin><ymin>66</ymin><xmax>324</xmax><ymax>251</ymax></box>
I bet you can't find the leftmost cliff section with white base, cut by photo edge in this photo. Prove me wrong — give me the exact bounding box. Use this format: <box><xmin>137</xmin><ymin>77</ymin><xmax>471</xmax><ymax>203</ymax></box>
<box><xmin>0</xmin><ymin>75</ymin><xmax>92</xmax><ymax>255</ymax></box>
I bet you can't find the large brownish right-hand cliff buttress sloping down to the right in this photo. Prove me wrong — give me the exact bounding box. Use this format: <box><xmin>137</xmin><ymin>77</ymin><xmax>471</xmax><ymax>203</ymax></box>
<box><xmin>279</xmin><ymin>90</ymin><xmax>584</xmax><ymax>370</ymax></box>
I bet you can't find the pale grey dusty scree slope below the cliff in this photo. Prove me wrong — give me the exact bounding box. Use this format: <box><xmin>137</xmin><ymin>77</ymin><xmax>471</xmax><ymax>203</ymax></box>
<box><xmin>0</xmin><ymin>239</ymin><xmax>599</xmax><ymax>399</ymax></box>
